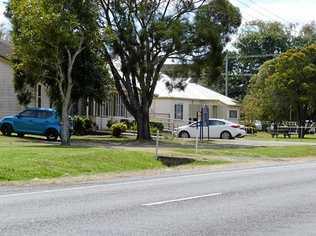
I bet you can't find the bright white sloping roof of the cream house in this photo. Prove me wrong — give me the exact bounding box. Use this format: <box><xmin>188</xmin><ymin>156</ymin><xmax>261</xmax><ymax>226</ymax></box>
<box><xmin>155</xmin><ymin>74</ymin><xmax>239</xmax><ymax>106</ymax></box>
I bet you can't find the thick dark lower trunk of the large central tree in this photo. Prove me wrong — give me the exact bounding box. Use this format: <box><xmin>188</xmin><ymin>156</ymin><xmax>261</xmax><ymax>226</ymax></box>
<box><xmin>136</xmin><ymin>111</ymin><xmax>152</xmax><ymax>141</ymax></box>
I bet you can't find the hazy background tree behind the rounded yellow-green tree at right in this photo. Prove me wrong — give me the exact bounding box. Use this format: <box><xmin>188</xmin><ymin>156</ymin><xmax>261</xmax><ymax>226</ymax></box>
<box><xmin>227</xmin><ymin>21</ymin><xmax>316</xmax><ymax>100</ymax></box>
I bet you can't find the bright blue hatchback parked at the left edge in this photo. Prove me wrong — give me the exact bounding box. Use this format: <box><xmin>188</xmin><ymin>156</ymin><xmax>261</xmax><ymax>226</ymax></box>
<box><xmin>0</xmin><ymin>108</ymin><xmax>68</xmax><ymax>141</ymax></box>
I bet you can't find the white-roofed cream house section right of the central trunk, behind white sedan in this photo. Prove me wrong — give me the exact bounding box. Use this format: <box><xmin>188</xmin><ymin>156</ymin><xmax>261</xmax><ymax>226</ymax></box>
<box><xmin>151</xmin><ymin>75</ymin><xmax>240</xmax><ymax>122</ymax></box>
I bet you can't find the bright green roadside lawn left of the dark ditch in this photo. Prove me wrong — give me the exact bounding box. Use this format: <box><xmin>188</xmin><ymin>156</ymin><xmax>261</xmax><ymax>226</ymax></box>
<box><xmin>0</xmin><ymin>135</ymin><xmax>227</xmax><ymax>181</ymax></box>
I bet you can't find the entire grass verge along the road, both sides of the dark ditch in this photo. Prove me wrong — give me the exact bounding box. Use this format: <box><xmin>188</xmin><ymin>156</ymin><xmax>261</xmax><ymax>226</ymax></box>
<box><xmin>0</xmin><ymin>135</ymin><xmax>316</xmax><ymax>181</ymax></box>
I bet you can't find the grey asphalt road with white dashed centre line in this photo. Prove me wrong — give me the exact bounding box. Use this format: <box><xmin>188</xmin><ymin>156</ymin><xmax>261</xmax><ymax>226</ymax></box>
<box><xmin>0</xmin><ymin>162</ymin><xmax>316</xmax><ymax>236</ymax></box>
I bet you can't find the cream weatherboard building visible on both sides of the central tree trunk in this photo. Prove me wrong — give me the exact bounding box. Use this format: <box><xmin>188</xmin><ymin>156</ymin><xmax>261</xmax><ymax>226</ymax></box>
<box><xmin>94</xmin><ymin>74</ymin><xmax>240</xmax><ymax>129</ymax></box>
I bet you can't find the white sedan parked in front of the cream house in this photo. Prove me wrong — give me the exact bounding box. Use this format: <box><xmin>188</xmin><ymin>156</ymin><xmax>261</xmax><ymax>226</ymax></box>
<box><xmin>176</xmin><ymin>119</ymin><xmax>246</xmax><ymax>139</ymax></box>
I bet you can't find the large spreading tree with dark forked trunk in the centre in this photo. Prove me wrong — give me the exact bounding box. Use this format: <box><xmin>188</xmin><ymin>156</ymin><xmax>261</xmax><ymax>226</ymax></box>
<box><xmin>99</xmin><ymin>0</ymin><xmax>240</xmax><ymax>140</ymax></box>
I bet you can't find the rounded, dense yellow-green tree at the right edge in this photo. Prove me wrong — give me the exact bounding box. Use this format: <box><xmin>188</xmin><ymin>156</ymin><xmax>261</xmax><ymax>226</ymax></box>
<box><xmin>244</xmin><ymin>44</ymin><xmax>316</xmax><ymax>135</ymax></box>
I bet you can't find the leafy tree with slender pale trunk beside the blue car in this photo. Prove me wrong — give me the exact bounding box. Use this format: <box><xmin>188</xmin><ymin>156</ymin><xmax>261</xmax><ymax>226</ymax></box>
<box><xmin>8</xmin><ymin>0</ymin><xmax>106</xmax><ymax>145</ymax></box>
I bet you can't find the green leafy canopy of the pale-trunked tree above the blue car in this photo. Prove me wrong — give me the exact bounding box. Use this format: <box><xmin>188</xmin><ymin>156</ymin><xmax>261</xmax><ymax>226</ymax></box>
<box><xmin>7</xmin><ymin>0</ymin><xmax>109</xmax><ymax>107</ymax></box>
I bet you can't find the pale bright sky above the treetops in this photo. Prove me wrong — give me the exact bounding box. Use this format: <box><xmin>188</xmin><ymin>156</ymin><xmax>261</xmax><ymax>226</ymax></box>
<box><xmin>0</xmin><ymin>0</ymin><xmax>316</xmax><ymax>29</ymax></box>
